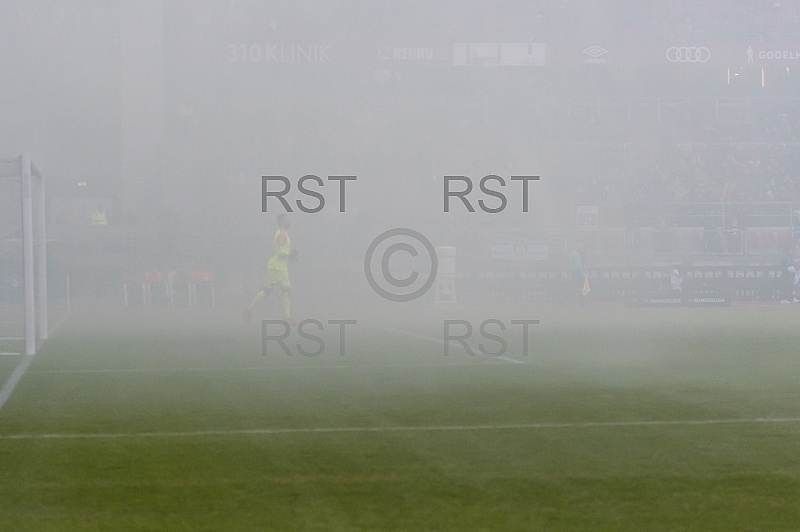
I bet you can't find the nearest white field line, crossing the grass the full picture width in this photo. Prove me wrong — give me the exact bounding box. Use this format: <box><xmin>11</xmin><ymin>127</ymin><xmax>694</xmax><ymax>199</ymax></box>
<box><xmin>0</xmin><ymin>417</ymin><xmax>800</xmax><ymax>440</ymax></box>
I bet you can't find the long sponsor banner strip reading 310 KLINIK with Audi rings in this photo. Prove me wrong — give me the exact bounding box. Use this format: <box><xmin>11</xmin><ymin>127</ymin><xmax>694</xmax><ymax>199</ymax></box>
<box><xmin>216</xmin><ymin>36</ymin><xmax>800</xmax><ymax>69</ymax></box>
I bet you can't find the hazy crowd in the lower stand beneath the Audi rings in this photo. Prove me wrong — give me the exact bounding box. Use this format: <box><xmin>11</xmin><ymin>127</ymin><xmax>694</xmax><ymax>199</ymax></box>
<box><xmin>542</xmin><ymin>99</ymin><xmax>800</xmax><ymax>209</ymax></box>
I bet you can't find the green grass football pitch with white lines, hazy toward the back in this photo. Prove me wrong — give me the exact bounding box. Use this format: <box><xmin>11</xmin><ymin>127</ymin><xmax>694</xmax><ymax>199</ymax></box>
<box><xmin>0</xmin><ymin>306</ymin><xmax>800</xmax><ymax>531</ymax></box>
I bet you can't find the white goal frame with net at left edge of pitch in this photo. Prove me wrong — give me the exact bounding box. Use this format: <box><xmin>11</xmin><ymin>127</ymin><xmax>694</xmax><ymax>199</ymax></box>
<box><xmin>0</xmin><ymin>154</ymin><xmax>48</xmax><ymax>355</ymax></box>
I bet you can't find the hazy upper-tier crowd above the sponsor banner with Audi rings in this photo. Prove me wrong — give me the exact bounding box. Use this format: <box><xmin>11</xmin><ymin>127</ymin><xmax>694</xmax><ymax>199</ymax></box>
<box><xmin>360</xmin><ymin>0</ymin><xmax>800</xmax><ymax>42</ymax></box>
